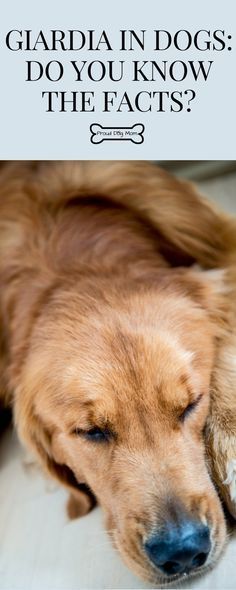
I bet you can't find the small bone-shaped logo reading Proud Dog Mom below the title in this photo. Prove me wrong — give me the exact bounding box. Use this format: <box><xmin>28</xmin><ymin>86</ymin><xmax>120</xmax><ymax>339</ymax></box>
<box><xmin>90</xmin><ymin>123</ymin><xmax>145</xmax><ymax>144</ymax></box>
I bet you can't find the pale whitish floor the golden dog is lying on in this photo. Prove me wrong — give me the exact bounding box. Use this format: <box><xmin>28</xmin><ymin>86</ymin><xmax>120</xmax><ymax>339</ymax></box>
<box><xmin>0</xmin><ymin>175</ymin><xmax>236</xmax><ymax>590</ymax></box>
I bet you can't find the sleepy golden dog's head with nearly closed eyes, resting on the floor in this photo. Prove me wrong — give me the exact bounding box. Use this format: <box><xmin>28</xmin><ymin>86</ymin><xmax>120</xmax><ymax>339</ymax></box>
<box><xmin>12</xmin><ymin>271</ymin><xmax>225</xmax><ymax>583</ymax></box>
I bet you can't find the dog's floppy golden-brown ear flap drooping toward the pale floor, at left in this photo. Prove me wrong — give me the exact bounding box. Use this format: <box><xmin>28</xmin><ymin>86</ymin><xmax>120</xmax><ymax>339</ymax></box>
<box><xmin>15</xmin><ymin>401</ymin><xmax>96</xmax><ymax>518</ymax></box>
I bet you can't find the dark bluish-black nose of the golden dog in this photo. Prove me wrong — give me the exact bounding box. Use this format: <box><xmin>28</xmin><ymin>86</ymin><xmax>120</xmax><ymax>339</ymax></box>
<box><xmin>144</xmin><ymin>521</ymin><xmax>211</xmax><ymax>576</ymax></box>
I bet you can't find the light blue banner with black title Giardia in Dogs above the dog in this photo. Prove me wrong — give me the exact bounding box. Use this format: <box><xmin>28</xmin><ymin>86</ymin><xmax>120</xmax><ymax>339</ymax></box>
<box><xmin>0</xmin><ymin>0</ymin><xmax>236</xmax><ymax>160</ymax></box>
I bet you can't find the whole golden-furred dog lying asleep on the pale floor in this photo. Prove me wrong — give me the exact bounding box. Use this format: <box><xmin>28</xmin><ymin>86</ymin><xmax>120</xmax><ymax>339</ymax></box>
<box><xmin>0</xmin><ymin>162</ymin><xmax>236</xmax><ymax>585</ymax></box>
